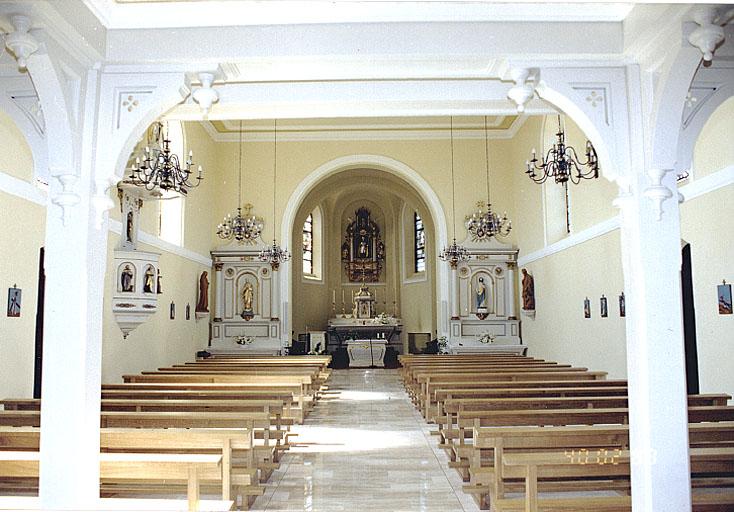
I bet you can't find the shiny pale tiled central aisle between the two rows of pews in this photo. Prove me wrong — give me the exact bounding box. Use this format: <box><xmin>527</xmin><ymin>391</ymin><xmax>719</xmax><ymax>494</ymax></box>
<box><xmin>253</xmin><ymin>369</ymin><xmax>479</xmax><ymax>512</ymax></box>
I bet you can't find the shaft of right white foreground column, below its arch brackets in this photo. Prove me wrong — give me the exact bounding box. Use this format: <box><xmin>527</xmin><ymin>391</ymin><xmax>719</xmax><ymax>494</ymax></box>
<box><xmin>618</xmin><ymin>172</ymin><xmax>691</xmax><ymax>512</ymax></box>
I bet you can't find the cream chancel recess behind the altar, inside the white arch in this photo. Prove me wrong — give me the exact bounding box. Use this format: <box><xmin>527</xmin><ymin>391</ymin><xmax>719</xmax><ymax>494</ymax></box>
<box><xmin>290</xmin><ymin>168</ymin><xmax>437</xmax><ymax>352</ymax></box>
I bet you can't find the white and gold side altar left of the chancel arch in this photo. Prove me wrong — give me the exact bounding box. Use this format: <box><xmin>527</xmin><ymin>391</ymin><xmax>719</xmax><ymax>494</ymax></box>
<box><xmin>209</xmin><ymin>244</ymin><xmax>281</xmax><ymax>355</ymax></box>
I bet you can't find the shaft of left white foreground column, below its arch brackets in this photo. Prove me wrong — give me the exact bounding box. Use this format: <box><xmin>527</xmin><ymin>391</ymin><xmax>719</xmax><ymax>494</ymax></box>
<box><xmin>39</xmin><ymin>173</ymin><xmax>108</xmax><ymax>510</ymax></box>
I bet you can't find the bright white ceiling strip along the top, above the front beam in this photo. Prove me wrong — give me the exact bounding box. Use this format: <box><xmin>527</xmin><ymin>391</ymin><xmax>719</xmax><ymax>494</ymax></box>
<box><xmin>84</xmin><ymin>0</ymin><xmax>634</xmax><ymax>29</ymax></box>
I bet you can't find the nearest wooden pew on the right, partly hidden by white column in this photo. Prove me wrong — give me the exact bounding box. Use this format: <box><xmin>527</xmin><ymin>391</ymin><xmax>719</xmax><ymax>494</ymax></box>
<box><xmin>493</xmin><ymin>448</ymin><xmax>734</xmax><ymax>512</ymax></box>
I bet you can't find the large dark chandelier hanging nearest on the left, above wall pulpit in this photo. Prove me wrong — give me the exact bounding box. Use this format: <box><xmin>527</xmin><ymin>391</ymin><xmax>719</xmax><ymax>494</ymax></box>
<box><xmin>125</xmin><ymin>122</ymin><xmax>204</xmax><ymax>195</ymax></box>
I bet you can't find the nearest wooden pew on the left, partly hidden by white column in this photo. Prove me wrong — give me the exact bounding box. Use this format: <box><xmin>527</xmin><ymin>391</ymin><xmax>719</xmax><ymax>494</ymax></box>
<box><xmin>0</xmin><ymin>451</ymin><xmax>227</xmax><ymax>510</ymax></box>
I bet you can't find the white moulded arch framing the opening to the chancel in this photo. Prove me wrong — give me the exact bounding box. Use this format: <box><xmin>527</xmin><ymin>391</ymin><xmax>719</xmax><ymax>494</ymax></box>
<box><xmin>280</xmin><ymin>155</ymin><xmax>449</xmax><ymax>343</ymax></box>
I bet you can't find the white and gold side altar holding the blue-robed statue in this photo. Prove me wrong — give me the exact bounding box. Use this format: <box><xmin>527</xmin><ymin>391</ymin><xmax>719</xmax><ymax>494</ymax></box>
<box><xmin>449</xmin><ymin>239</ymin><xmax>525</xmax><ymax>353</ymax></box>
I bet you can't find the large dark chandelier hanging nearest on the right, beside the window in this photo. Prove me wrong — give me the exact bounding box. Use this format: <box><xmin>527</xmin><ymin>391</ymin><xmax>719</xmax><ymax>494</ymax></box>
<box><xmin>525</xmin><ymin>116</ymin><xmax>599</xmax><ymax>185</ymax></box>
